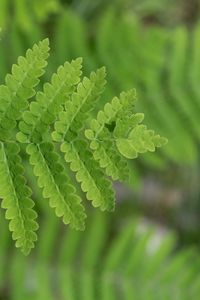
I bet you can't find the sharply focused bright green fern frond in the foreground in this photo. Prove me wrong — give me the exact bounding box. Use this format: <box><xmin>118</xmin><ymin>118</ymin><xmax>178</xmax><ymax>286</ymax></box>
<box><xmin>0</xmin><ymin>39</ymin><xmax>166</xmax><ymax>254</ymax></box>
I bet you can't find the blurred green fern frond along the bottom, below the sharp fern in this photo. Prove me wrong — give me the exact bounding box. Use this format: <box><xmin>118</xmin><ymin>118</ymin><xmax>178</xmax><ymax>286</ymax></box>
<box><xmin>0</xmin><ymin>211</ymin><xmax>200</xmax><ymax>300</ymax></box>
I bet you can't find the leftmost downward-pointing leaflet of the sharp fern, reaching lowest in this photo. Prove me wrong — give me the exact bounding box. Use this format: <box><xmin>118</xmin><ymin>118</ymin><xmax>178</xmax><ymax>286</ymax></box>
<box><xmin>0</xmin><ymin>142</ymin><xmax>38</xmax><ymax>255</ymax></box>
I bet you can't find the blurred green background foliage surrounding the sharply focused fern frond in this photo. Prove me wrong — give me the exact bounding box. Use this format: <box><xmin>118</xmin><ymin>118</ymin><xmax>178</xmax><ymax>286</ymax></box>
<box><xmin>0</xmin><ymin>0</ymin><xmax>200</xmax><ymax>300</ymax></box>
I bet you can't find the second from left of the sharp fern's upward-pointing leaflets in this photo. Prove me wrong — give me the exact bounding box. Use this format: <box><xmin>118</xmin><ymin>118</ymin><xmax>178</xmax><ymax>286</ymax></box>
<box><xmin>17</xmin><ymin>58</ymin><xmax>82</xmax><ymax>143</ymax></box>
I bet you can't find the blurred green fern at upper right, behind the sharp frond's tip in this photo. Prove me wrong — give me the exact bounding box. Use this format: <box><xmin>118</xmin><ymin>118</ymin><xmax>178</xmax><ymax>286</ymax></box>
<box><xmin>48</xmin><ymin>8</ymin><xmax>200</xmax><ymax>169</ymax></box>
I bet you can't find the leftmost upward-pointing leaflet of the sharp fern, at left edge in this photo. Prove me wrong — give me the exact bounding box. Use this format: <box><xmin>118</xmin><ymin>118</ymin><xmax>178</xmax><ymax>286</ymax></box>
<box><xmin>0</xmin><ymin>39</ymin><xmax>49</xmax><ymax>139</ymax></box>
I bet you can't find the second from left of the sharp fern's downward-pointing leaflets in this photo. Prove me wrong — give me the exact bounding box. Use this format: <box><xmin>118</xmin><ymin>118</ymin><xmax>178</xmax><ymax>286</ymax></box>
<box><xmin>27</xmin><ymin>143</ymin><xmax>86</xmax><ymax>230</ymax></box>
